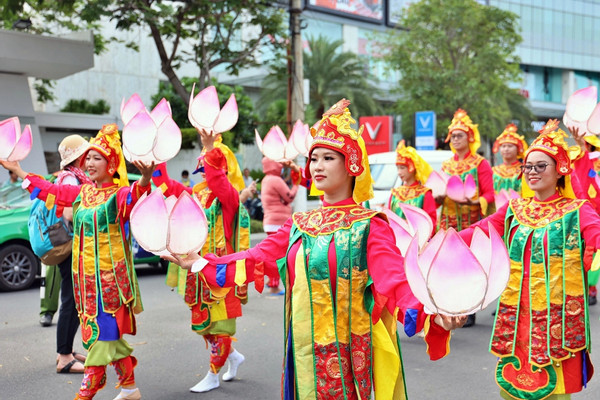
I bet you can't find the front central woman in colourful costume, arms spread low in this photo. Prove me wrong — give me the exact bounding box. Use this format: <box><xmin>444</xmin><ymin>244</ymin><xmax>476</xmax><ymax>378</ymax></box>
<box><xmin>165</xmin><ymin>100</ymin><xmax>465</xmax><ymax>400</ymax></box>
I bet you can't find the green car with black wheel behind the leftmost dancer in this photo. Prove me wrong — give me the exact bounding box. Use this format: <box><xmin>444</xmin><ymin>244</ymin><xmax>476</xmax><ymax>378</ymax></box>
<box><xmin>0</xmin><ymin>174</ymin><xmax>168</xmax><ymax>291</ymax></box>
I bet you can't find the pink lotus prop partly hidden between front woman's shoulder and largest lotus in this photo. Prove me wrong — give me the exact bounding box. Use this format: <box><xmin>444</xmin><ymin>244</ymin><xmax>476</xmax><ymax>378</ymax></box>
<box><xmin>383</xmin><ymin>203</ymin><xmax>433</xmax><ymax>256</ymax></box>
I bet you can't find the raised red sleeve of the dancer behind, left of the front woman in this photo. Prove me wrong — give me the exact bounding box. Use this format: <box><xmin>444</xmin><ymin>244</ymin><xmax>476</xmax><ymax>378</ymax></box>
<box><xmin>204</xmin><ymin>147</ymin><xmax>240</xmax><ymax>241</ymax></box>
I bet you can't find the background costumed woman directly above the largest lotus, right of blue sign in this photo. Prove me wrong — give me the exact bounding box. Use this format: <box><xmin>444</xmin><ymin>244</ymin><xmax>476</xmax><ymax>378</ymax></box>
<box><xmin>435</xmin><ymin>108</ymin><xmax>494</xmax><ymax>231</ymax></box>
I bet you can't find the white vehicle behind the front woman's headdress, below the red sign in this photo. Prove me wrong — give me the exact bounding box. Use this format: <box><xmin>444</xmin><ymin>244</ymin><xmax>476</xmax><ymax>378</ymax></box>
<box><xmin>369</xmin><ymin>150</ymin><xmax>453</xmax><ymax>210</ymax></box>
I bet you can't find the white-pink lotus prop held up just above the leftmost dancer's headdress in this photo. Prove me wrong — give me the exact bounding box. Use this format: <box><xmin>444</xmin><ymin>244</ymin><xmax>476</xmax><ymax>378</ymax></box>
<box><xmin>121</xmin><ymin>94</ymin><xmax>181</xmax><ymax>164</ymax></box>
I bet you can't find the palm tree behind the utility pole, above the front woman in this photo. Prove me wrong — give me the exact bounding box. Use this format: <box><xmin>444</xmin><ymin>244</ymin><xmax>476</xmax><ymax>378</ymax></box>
<box><xmin>259</xmin><ymin>36</ymin><xmax>380</xmax><ymax>123</ymax></box>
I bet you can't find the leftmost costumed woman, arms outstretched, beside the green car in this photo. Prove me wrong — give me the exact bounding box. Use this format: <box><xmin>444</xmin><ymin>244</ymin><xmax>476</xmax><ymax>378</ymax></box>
<box><xmin>2</xmin><ymin>124</ymin><xmax>154</xmax><ymax>400</ymax></box>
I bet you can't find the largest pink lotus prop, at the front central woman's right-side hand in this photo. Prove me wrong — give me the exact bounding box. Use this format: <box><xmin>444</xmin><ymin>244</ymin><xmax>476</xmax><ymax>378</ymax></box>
<box><xmin>405</xmin><ymin>225</ymin><xmax>510</xmax><ymax>315</ymax></box>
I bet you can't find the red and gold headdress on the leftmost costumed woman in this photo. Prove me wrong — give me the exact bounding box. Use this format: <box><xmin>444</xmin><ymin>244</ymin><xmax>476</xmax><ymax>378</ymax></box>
<box><xmin>81</xmin><ymin>124</ymin><xmax>129</xmax><ymax>186</ymax></box>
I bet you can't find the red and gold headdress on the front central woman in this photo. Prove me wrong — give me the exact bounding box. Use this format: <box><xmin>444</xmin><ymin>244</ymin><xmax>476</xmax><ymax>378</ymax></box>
<box><xmin>305</xmin><ymin>99</ymin><xmax>373</xmax><ymax>203</ymax></box>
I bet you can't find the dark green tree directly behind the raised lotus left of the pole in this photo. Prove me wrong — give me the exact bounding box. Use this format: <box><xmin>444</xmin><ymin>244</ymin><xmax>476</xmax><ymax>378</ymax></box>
<box><xmin>152</xmin><ymin>77</ymin><xmax>258</xmax><ymax>151</ymax></box>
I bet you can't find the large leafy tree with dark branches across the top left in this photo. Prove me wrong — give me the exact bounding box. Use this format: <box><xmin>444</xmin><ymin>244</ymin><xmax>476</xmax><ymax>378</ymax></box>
<box><xmin>0</xmin><ymin>0</ymin><xmax>285</xmax><ymax>104</ymax></box>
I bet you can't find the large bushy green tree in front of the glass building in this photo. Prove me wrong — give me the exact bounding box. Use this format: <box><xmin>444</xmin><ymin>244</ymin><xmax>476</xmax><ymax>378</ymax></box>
<box><xmin>383</xmin><ymin>0</ymin><xmax>532</xmax><ymax>146</ymax></box>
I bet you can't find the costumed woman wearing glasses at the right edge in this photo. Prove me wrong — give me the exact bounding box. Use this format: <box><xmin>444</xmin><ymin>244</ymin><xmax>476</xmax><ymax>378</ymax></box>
<box><xmin>460</xmin><ymin>120</ymin><xmax>600</xmax><ymax>400</ymax></box>
